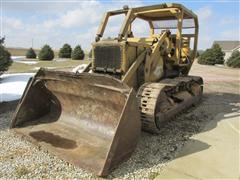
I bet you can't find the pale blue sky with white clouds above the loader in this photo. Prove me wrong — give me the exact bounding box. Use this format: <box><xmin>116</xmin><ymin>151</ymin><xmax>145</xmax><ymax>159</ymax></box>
<box><xmin>0</xmin><ymin>0</ymin><xmax>240</xmax><ymax>50</ymax></box>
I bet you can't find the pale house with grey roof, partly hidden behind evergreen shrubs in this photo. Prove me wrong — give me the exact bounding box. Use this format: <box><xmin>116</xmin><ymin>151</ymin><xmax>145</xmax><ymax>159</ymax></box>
<box><xmin>213</xmin><ymin>41</ymin><xmax>240</xmax><ymax>63</ymax></box>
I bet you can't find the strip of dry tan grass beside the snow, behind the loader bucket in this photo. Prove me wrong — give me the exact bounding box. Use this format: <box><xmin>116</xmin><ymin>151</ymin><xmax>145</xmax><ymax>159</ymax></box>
<box><xmin>7</xmin><ymin>60</ymin><xmax>90</xmax><ymax>73</ymax></box>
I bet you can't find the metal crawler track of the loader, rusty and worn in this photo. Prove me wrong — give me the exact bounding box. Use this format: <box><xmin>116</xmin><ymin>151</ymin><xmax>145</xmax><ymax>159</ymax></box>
<box><xmin>137</xmin><ymin>76</ymin><xmax>203</xmax><ymax>133</ymax></box>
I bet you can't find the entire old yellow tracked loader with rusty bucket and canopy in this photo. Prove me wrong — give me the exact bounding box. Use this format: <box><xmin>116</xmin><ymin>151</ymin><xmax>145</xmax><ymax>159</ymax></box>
<box><xmin>11</xmin><ymin>4</ymin><xmax>203</xmax><ymax>176</ymax></box>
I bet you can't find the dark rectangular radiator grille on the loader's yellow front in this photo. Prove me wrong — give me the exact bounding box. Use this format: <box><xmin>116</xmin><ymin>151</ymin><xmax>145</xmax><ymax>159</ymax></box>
<box><xmin>94</xmin><ymin>46</ymin><xmax>122</xmax><ymax>70</ymax></box>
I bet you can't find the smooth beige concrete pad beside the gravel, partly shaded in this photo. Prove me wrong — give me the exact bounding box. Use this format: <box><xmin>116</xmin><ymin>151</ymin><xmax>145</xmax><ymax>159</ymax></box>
<box><xmin>156</xmin><ymin>113</ymin><xmax>240</xmax><ymax>180</ymax></box>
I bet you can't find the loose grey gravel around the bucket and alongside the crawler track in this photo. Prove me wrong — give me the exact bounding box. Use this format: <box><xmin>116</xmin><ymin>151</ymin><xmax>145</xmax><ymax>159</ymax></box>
<box><xmin>0</xmin><ymin>101</ymin><xmax>210</xmax><ymax>178</ymax></box>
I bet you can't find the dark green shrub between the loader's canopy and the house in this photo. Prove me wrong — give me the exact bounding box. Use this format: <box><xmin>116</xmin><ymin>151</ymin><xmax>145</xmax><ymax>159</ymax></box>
<box><xmin>198</xmin><ymin>44</ymin><xmax>225</xmax><ymax>65</ymax></box>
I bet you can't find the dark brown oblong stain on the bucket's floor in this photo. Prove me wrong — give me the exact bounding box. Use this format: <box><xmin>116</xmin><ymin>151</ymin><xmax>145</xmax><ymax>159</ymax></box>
<box><xmin>29</xmin><ymin>131</ymin><xmax>77</xmax><ymax>149</ymax></box>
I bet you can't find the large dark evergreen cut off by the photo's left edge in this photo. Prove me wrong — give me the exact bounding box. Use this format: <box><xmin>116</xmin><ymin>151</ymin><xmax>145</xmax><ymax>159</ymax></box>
<box><xmin>0</xmin><ymin>44</ymin><xmax>12</xmax><ymax>75</ymax></box>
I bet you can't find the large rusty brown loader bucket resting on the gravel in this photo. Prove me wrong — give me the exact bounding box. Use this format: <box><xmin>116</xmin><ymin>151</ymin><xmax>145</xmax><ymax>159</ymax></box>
<box><xmin>11</xmin><ymin>69</ymin><xmax>141</xmax><ymax>176</ymax></box>
